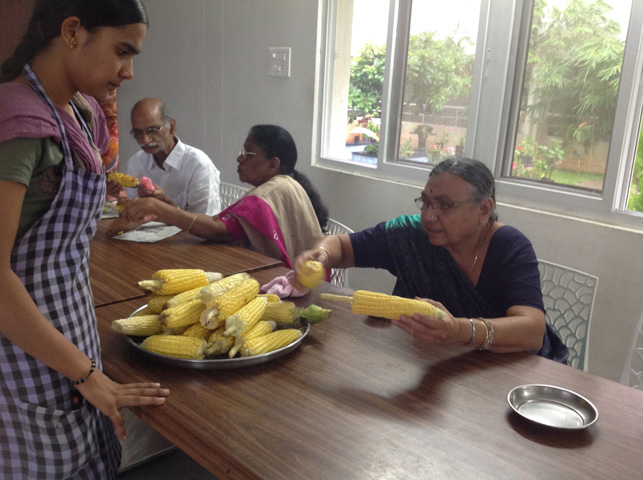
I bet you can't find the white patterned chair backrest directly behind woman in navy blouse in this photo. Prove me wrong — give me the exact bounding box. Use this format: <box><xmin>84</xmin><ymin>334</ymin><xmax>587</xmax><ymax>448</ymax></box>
<box><xmin>538</xmin><ymin>260</ymin><xmax>598</xmax><ymax>370</ymax></box>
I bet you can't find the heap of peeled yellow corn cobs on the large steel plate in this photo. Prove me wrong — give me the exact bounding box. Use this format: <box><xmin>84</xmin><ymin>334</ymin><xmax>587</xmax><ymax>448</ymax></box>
<box><xmin>112</xmin><ymin>269</ymin><xmax>330</xmax><ymax>360</ymax></box>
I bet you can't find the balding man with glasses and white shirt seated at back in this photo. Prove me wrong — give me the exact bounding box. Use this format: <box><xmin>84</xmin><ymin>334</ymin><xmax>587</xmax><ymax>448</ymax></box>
<box><xmin>115</xmin><ymin>98</ymin><xmax>221</xmax><ymax>215</ymax></box>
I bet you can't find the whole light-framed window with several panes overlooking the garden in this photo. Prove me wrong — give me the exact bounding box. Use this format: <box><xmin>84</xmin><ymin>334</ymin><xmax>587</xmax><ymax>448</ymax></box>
<box><xmin>316</xmin><ymin>0</ymin><xmax>643</xmax><ymax>227</ymax></box>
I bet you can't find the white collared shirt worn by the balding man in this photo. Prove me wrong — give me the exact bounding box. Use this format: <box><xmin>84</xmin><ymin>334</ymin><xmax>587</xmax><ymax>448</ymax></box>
<box><xmin>127</xmin><ymin>137</ymin><xmax>221</xmax><ymax>215</ymax></box>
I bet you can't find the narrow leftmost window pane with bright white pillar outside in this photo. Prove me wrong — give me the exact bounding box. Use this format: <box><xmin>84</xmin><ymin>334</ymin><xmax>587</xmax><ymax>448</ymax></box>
<box><xmin>323</xmin><ymin>0</ymin><xmax>389</xmax><ymax>165</ymax></box>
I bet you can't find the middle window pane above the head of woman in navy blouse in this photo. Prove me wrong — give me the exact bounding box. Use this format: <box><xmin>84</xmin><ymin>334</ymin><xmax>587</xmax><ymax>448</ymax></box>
<box><xmin>398</xmin><ymin>0</ymin><xmax>480</xmax><ymax>165</ymax></box>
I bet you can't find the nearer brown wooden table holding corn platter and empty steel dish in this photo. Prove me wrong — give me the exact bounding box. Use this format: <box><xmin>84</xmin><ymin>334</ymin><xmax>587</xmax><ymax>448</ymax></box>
<box><xmin>96</xmin><ymin>267</ymin><xmax>643</xmax><ymax>480</ymax></box>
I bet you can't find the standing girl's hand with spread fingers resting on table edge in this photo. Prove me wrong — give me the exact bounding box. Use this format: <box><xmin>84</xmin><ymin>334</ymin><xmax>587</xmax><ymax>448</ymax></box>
<box><xmin>76</xmin><ymin>370</ymin><xmax>170</xmax><ymax>440</ymax></box>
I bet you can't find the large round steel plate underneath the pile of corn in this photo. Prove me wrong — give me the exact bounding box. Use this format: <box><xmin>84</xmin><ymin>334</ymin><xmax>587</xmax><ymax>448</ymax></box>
<box><xmin>126</xmin><ymin>305</ymin><xmax>310</xmax><ymax>370</ymax></box>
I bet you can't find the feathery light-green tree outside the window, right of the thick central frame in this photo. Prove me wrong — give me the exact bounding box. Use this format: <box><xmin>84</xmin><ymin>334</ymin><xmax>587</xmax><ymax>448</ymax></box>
<box><xmin>523</xmin><ymin>0</ymin><xmax>624</xmax><ymax>148</ymax></box>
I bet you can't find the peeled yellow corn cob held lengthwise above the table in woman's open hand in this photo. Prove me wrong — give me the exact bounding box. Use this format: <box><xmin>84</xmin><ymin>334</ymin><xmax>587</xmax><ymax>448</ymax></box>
<box><xmin>319</xmin><ymin>290</ymin><xmax>445</xmax><ymax>320</ymax></box>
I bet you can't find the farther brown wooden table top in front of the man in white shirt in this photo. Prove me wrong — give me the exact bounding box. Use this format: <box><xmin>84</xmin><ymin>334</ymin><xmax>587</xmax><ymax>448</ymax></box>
<box><xmin>89</xmin><ymin>218</ymin><xmax>283</xmax><ymax>307</ymax></box>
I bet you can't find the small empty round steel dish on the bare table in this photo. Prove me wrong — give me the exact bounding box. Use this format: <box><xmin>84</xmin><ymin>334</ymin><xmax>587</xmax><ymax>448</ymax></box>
<box><xmin>507</xmin><ymin>385</ymin><xmax>598</xmax><ymax>430</ymax></box>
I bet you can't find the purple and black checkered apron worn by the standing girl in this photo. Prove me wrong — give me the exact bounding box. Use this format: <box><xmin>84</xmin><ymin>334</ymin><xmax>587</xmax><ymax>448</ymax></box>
<box><xmin>0</xmin><ymin>66</ymin><xmax>121</xmax><ymax>480</ymax></box>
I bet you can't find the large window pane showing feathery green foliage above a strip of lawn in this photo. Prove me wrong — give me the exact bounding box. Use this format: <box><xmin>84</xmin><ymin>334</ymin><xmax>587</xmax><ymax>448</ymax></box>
<box><xmin>511</xmin><ymin>0</ymin><xmax>632</xmax><ymax>192</ymax></box>
